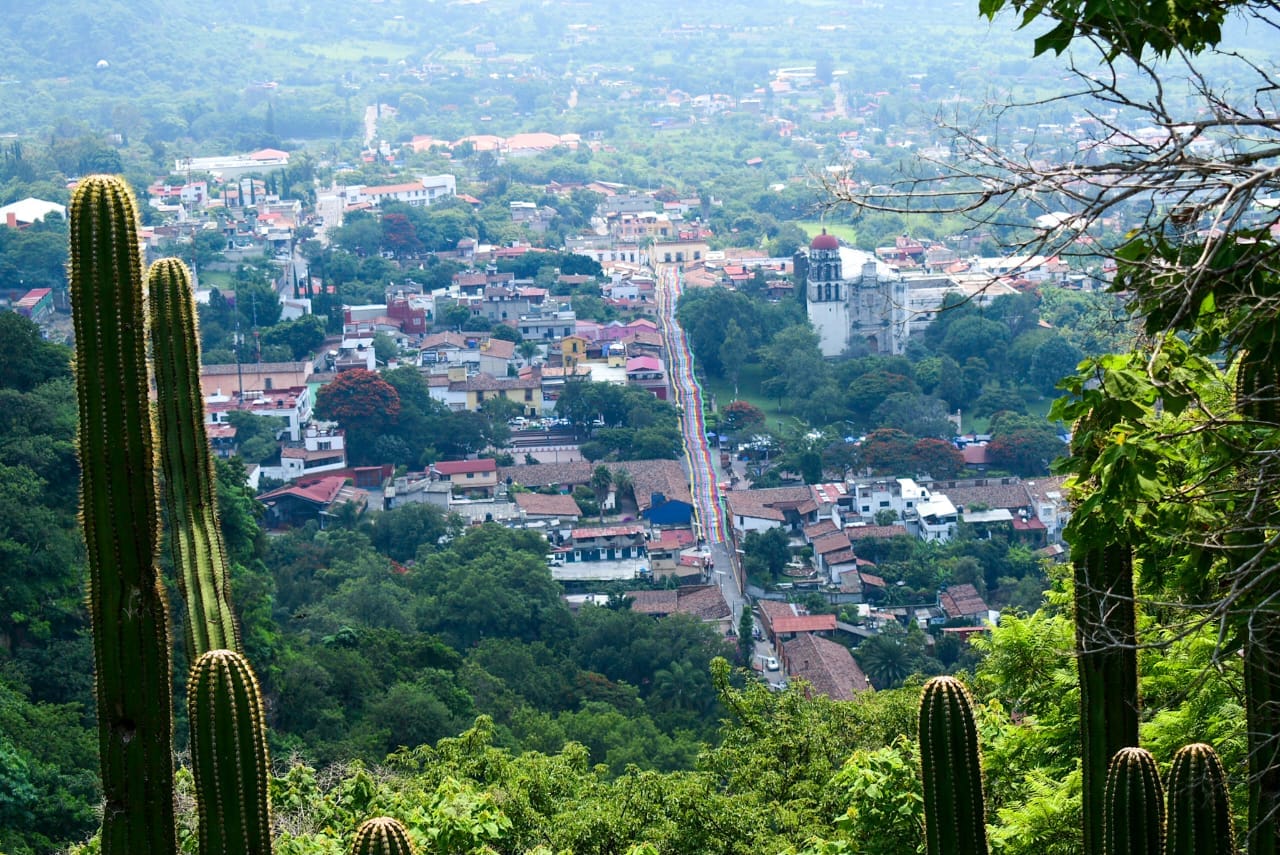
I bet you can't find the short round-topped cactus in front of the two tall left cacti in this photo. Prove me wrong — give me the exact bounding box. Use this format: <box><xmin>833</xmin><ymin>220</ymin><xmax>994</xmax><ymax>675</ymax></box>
<box><xmin>187</xmin><ymin>650</ymin><xmax>271</xmax><ymax>855</ymax></box>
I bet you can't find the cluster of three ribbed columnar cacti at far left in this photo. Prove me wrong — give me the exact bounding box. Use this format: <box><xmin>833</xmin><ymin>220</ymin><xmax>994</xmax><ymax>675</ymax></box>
<box><xmin>70</xmin><ymin>175</ymin><xmax>270</xmax><ymax>855</ymax></box>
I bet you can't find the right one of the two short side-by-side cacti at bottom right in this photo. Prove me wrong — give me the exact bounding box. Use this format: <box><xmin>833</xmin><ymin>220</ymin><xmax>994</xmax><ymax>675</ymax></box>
<box><xmin>1165</xmin><ymin>742</ymin><xmax>1235</xmax><ymax>855</ymax></box>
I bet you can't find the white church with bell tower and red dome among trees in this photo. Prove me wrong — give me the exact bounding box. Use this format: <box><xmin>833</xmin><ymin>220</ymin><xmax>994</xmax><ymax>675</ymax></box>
<box><xmin>805</xmin><ymin>232</ymin><xmax>909</xmax><ymax>357</ymax></box>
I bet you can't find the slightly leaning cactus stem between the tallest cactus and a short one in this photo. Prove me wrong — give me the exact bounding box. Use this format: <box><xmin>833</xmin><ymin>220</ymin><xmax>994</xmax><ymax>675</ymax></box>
<box><xmin>147</xmin><ymin>259</ymin><xmax>241</xmax><ymax>660</ymax></box>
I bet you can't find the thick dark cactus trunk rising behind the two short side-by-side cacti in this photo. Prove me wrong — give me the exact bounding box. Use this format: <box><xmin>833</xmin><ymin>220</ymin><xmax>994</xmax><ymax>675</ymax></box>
<box><xmin>1075</xmin><ymin>544</ymin><xmax>1138</xmax><ymax>852</ymax></box>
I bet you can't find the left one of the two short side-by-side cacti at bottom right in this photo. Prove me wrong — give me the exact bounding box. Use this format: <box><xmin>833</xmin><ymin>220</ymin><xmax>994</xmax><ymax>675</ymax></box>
<box><xmin>1102</xmin><ymin>746</ymin><xmax>1165</xmax><ymax>855</ymax></box>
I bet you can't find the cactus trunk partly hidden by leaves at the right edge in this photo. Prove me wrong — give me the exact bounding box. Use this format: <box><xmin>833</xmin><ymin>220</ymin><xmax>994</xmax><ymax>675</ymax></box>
<box><xmin>1231</xmin><ymin>350</ymin><xmax>1280</xmax><ymax>855</ymax></box>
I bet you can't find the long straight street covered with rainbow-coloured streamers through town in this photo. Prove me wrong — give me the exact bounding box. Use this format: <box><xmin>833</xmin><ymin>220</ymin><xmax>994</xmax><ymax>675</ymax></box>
<box><xmin>657</xmin><ymin>268</ymin><xmax>746</xmax><ymax>618</ymax></box>
